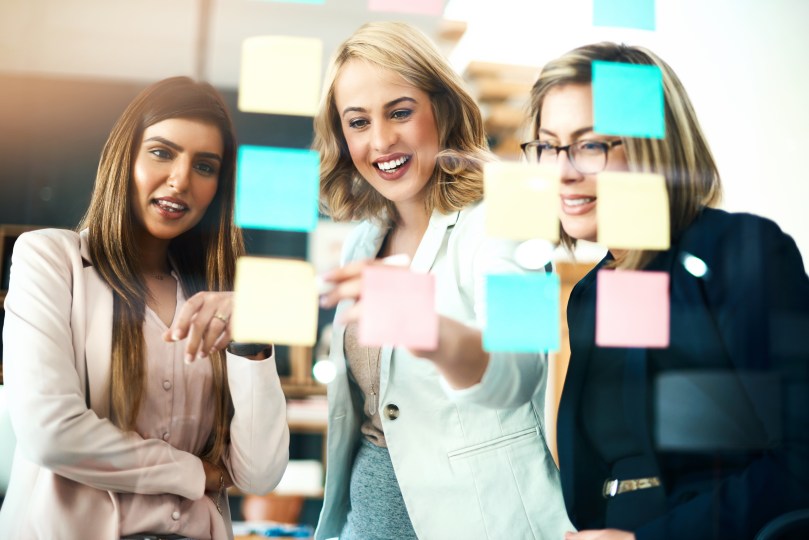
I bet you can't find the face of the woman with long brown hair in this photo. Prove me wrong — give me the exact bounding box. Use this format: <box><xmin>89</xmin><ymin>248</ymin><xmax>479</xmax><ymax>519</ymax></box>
<box><xmin>131</xmin><ymin>118</ymin><xmax>224</xmax><ymax>245</ymax></box>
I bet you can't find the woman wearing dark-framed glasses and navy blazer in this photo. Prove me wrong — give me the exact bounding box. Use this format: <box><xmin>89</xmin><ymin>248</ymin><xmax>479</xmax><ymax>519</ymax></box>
<box><xmin>523</xmin><ymin>43</ymin><xmax>809</xmax><ymax>540</ymax></box>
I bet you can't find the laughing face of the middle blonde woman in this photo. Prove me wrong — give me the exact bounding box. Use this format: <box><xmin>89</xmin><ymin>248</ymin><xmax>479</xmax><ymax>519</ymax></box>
<box><xmin>334</xmin><ymin>60</ymin><xmax>439</xmax><ymax>212</ymax></box>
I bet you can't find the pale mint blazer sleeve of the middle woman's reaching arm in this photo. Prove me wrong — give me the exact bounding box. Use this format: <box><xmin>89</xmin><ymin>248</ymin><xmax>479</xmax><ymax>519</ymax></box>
<box><xmin>441</xmin><ymin>205</ymin><xmax>548</xmax><ymax>409</ymax></box>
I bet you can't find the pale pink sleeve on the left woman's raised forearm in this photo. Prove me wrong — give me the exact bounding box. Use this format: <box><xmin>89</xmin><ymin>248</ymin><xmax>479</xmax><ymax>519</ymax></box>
<box><xmin>226</xmin><ymin>347</ymin><xmax>289</xmax><ymax>495</ymax></box>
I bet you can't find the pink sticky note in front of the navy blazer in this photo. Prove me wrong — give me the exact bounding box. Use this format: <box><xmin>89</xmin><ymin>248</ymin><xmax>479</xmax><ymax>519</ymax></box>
<box><xmin>596</xmin><ymin>270</ymin><xmax>669</xmax><ymax>348</ymax></box>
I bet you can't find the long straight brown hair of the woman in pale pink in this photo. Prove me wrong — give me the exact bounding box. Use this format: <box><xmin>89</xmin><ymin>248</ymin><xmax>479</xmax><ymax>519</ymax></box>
<box><xmin>79</xmin><ymin>77</ymin><xmax>244</xmax><ymax>463</ymax></box>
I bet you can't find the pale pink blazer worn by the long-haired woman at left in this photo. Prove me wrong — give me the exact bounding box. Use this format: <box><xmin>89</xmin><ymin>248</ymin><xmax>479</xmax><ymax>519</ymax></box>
<box><xmin>0</xmin><ymin>229</ymin><xmax>289</xmax><ymax>540</ymax></box>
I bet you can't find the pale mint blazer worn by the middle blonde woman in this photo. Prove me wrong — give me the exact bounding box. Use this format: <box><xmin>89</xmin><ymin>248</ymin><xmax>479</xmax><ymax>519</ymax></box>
<box><xmin>315</xmin><ymin>205</ymin><xmax>574</xmax><ymax>540</ymax></box>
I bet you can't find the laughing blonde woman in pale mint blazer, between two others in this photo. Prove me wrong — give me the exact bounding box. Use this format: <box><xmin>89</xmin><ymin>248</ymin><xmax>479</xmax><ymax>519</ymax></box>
<box><xmin>314</xmin><ymin>23</ymin><xmax>570</xmax><ymax>539</ymax></box>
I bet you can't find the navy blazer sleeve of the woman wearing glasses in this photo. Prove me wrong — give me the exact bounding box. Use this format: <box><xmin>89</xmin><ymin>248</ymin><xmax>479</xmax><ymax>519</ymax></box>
<box><xmin>636</xmin><ymin>216</ymin><xmax>809</xmax><ymax>540</ymax></box>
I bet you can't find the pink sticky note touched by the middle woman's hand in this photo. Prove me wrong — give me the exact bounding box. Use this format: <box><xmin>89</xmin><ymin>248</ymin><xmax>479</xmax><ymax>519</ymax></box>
<box><xmin>359</xmin><ymin>266</ymin><xmax>438</xmax><ymax>351</ymax></box>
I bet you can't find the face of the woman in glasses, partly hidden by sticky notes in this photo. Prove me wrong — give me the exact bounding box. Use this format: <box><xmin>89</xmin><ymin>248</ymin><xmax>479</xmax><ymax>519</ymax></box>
<box><xmin>538</xmin><ymin>84</ymin><xmax>629</xmax><ymax>242</ymax></box>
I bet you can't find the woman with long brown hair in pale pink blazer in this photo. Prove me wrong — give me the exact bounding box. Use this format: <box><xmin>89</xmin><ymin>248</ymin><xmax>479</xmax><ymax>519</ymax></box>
<box><xmin>0</xmin><ymin>77</ymin><xmax>289</xmax><ymax>540</ymax></box>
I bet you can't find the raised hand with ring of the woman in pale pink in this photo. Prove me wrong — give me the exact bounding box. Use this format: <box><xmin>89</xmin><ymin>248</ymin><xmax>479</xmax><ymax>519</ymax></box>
<box><xmin>163</xmin><ymin>291</ymin><xmax>233</xmax><ymax>364</ymax></box>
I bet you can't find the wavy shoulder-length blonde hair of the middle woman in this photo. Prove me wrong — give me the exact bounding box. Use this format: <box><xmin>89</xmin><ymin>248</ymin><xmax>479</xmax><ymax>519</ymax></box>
<box><xmin>312</xmin><ymin>22</ymin><xmax>493</xmax><ymax>221</ymax></box>
